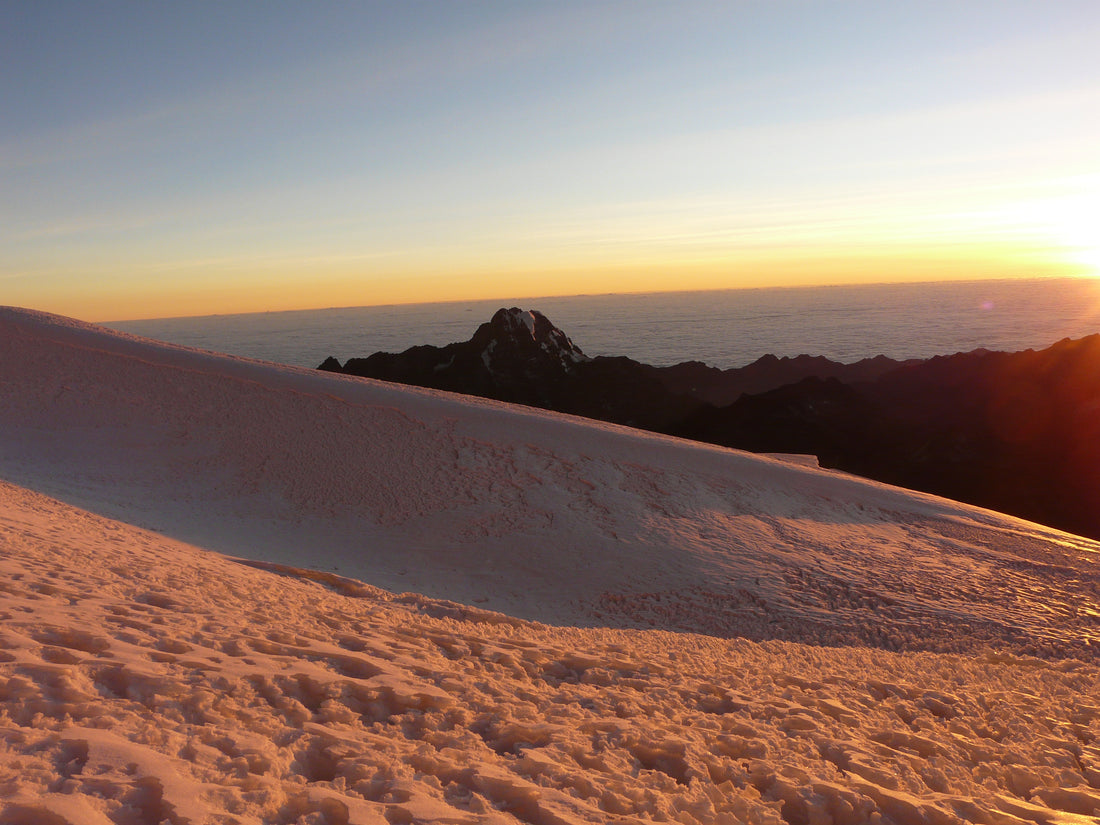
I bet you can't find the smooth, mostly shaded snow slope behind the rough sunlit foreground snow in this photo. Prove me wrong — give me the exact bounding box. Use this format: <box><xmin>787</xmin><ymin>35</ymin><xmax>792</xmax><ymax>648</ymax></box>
<box><xmin>0</xmin><ymin>308</ymin><xmax>1100</xmax><ymax>658</ymax></box>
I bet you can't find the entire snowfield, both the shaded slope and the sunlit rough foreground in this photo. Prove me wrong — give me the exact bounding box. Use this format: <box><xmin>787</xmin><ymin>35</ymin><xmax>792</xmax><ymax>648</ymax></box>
<box><xmin>0</xmin><ymin>309</ymin><xmax>1100</xmax><ymax>825</ymax></box>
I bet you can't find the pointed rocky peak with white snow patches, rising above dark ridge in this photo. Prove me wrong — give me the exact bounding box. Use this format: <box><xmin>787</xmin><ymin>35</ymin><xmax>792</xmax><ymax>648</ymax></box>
<box><xmin>471</xmin><ymin>307</ymin><xmax>590</xmax><ymax>372</ymax></box>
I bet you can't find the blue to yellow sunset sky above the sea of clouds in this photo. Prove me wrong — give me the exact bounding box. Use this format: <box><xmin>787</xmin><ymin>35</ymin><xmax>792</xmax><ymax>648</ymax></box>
<box><xmin>0</xmin><ymin>0</ymin><xmax>1100</xmax><ymax>321</ymax></box>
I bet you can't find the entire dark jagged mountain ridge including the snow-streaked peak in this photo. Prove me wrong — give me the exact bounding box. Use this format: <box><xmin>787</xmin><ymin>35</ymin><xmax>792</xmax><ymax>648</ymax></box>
<box><xmin>320</xmin><ymin>307</ymin><xmax>1100</xmax><ymax>538</ymax></box>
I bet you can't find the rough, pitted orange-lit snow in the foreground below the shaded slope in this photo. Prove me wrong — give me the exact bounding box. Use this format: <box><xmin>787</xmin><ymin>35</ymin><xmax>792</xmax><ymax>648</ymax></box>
<box><xmin>0</xmin><ymin>483</ymin><xmax>1100</xmax><ymax>825</ymax></box>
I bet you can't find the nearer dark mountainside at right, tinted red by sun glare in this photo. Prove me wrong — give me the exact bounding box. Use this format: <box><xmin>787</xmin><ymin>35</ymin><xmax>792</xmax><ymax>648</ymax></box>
<box><xmin>674</xmin><ymin>336</ymin><xmax>1100</xmax><ymax>538</ymax></box>
